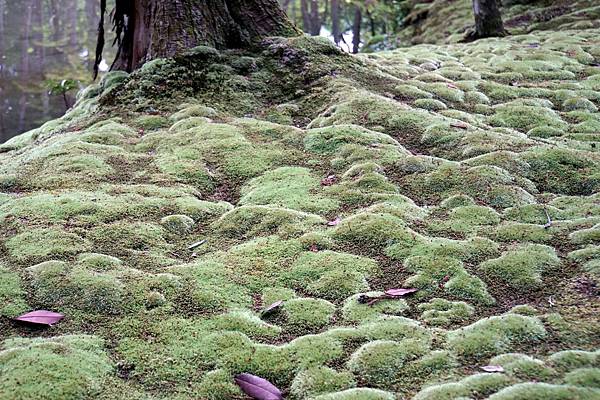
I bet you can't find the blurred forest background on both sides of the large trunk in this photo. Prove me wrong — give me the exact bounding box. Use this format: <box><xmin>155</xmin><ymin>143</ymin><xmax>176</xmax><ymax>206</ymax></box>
<box><xmin>0</xmin><ymin>0</ymin><xmax>410</xmax><ymax>143</ymax></box>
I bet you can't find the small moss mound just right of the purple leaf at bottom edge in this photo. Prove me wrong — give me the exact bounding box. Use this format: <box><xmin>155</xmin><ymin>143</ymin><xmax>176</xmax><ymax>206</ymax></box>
<box><xmin>290</xmin><ymin>367</ymin><xmax>356</xmax><ymax>399</ymax></box>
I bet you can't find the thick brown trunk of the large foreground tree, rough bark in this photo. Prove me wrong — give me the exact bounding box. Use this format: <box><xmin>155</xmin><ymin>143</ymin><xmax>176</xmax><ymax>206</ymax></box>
<box><xmin>106</xmin><ymin>0</ymin><xmax>298</xmax><ymax>71</ymax></box>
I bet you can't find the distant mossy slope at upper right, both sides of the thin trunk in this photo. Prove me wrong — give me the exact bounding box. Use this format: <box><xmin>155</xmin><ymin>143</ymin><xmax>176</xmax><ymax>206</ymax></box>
<box><xmin>365</xmin><ymin>0</ymin><xmax>600</xmax><ymax>51</ymax></box>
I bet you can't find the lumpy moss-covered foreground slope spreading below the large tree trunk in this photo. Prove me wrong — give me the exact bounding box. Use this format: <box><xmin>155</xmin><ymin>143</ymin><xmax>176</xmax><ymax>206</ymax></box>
<box><xmin>0</xmin><ymin>29</ymin><xmax>600</xmax><ymax>400</ymax></box>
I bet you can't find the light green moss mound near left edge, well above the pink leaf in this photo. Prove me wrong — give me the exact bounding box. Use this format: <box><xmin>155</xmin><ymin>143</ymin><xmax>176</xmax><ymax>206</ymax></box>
<box><xmin>6</xmin><ymin>228</ymin><xmax>90</xmax><ymax>264</ymax></box>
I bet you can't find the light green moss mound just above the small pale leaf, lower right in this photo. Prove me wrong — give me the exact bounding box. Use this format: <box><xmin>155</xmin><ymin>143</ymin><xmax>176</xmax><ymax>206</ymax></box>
<box><xmin>448</xmin><ymin>314</ymin><xmax>546</xmax><ymax>359</ymax></box>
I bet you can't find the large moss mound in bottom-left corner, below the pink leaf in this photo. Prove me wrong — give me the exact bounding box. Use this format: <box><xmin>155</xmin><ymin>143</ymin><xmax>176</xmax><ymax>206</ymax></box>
<box><xmin>0</xmin><ymin>335</ymin><xmax>113</xmax><ymax>400</ymax></box>
